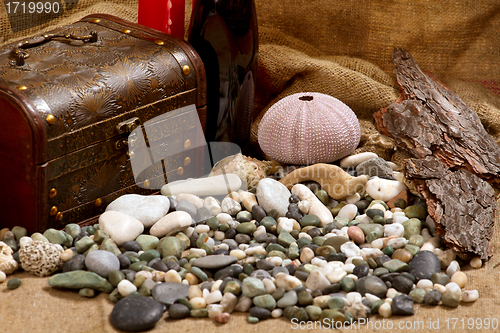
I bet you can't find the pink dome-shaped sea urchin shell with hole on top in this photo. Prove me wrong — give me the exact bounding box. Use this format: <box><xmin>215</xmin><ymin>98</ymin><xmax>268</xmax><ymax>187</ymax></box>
<box><xmin>258</xmin><ymin>93</ymin><xmax>361</xmax><ymax>165</ymax></box>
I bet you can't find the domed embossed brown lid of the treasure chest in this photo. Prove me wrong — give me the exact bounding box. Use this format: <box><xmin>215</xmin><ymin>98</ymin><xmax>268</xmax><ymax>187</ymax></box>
<box><xmin>0</xmin><ymin>15</ymin><xmax>205</xmax><ymax>163</ymax></box>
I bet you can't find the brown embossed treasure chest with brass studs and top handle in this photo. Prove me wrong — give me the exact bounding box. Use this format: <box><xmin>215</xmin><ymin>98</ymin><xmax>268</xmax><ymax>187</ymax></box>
<box><xmin>0</xmin><ymin>15</ymin><xmax>209</xmax><ymax>232</ymax></box>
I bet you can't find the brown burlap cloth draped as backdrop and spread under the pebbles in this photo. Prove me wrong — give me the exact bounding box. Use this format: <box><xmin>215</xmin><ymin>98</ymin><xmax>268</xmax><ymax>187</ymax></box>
<box><xmin>0</xmin><ymin>0</ymin><xmax>500</xmax><ymax>333</ymax></box>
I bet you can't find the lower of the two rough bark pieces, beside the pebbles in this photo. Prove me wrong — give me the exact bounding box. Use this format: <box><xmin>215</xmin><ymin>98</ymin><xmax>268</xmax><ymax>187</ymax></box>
<box><xmin>404</xmin><ymin>156</ymin><xmax>496</xmax><ymax>260</ymax></box>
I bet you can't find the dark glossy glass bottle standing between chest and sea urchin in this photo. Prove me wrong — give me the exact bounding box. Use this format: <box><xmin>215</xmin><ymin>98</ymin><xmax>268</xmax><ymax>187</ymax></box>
<box><xmin>188</xmin><ymin>0</ymin><xmax>258</xmax><ymax>153</ymax></box>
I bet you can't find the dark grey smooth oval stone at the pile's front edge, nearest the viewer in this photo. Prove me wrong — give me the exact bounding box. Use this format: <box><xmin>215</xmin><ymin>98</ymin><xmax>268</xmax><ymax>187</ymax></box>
<box><xmin>111</xmin><ymin>296</ymin><xmax>165</xmax><ymax>332</ymax></box>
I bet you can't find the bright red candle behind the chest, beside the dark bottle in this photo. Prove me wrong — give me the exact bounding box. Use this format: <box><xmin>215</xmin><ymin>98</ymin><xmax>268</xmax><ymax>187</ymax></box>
<box><xmin>138</xmin><ymin>0</ymin><xmax>185</xmax><ymax>39</ymax></box>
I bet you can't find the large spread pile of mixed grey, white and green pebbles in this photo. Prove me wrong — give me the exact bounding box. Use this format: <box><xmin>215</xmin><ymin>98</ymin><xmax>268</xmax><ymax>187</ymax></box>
<box><xmin>0</xmin><ymin>153</ymin><xmax>482</xmax><ymax>331</ymax></box>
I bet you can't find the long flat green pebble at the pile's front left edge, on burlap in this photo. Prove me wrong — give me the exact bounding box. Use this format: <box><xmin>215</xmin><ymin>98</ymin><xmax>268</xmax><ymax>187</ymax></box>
<box><xmin>47</xmin><ymin>271</ymin><xmax>114</xmax><ymax>293</ymax></box>
